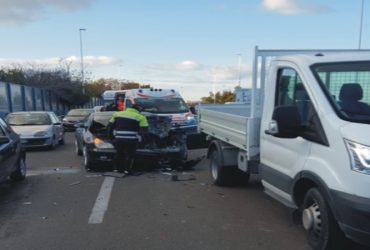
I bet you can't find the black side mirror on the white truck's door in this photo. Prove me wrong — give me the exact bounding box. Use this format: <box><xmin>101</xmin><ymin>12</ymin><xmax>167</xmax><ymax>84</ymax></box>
<box><xmin>265</xmin><ymin>105</ymin><xmax>303</xmax><ymax>138</ymax></box>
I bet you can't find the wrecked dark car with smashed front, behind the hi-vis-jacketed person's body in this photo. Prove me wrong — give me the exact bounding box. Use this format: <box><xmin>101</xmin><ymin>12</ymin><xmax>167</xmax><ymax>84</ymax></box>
<box><xmin>75</xmin><ymin>112</ymin><xmax>187</xmax><ymax>170</ymax></box>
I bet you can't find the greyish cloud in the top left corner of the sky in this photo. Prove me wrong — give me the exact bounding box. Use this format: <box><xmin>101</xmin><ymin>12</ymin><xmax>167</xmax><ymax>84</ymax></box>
<box><xmin>0</xmin><ymin>0</ymin><xmax>95</xmax><ymax>25</ymax></box>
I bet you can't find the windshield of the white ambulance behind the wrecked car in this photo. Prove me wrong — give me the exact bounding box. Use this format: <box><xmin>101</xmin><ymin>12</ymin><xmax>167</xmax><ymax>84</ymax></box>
<box><xmin>135</xmin><ymin>98</ymin><xmax>189</xmax><ymax>114</ymax></box>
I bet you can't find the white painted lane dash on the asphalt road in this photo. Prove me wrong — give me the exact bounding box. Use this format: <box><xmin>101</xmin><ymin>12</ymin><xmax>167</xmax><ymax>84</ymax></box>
<box><xmin>89</xmin><ymin>177</ymin><xmax>115</xmax><ymax>224</ymax></box>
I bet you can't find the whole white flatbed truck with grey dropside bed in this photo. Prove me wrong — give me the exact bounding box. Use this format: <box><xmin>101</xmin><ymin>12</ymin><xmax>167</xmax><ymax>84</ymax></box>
<box><xmin>198</xmin><ymin>47</ymin><xmax>370</xmax><ymax>250</ymax></box>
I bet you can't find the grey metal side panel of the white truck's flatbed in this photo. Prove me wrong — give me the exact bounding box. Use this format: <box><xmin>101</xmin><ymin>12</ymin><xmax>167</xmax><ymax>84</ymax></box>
<box><xmin>199</xmin><ymin>109</ymin><xmax>248</xmax><ymax>151</ymax></box>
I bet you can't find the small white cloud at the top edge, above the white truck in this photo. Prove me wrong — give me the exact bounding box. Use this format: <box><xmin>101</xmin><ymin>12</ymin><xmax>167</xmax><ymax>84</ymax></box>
<box><xmin>262</xmin><ymin>0</ymin><xmax>330</xmax><ymax>16</ymax></box>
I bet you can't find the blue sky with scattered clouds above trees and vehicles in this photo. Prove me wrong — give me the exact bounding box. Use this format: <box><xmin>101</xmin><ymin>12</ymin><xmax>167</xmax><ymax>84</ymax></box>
<box><xmin>0</xmin><ymin>0</ymin><xmax>370</xmax><ymax>100</ymax></box>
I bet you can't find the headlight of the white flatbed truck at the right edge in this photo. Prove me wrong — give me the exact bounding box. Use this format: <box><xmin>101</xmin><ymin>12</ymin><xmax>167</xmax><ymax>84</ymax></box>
<box><xmin>344</xmin><ymin>139</ymin><xmax>370</xmax><ymax>175</ymax></box>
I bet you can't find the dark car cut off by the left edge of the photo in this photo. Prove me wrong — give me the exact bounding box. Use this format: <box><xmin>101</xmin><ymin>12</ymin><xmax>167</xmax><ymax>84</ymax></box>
<box><xmin>0</xmin><ymin>118</ymin><xmax>26</xmax><ymax>181</ymax></box>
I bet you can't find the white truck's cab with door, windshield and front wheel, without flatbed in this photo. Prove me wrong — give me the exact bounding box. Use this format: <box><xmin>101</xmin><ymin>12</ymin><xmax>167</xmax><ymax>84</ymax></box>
<box><xmin>260</xmin><ymin>53</ymin><xmax>370</xmax><ymax>248</ymax></box>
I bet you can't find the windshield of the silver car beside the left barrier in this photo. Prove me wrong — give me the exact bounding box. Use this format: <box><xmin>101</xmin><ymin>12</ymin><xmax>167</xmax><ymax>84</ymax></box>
<box><xmin>6</xmin><ymin>113</ymin><xmax>51</xmax><ymax>126</ymax></box>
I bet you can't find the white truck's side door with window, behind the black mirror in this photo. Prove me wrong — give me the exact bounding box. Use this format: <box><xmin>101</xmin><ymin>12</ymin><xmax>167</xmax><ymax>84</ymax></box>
<box><xmin>260</xmin><ymin>64</ymin><xmax>313</xmax><ymax>203</ymax></box>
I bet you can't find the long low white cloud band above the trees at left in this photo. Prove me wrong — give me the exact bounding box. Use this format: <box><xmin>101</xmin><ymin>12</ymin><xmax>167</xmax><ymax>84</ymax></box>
<box><xmin>0</xmin><ymin>56</ymin><xmax>121</xmax><ymax>67</ymax></box>
